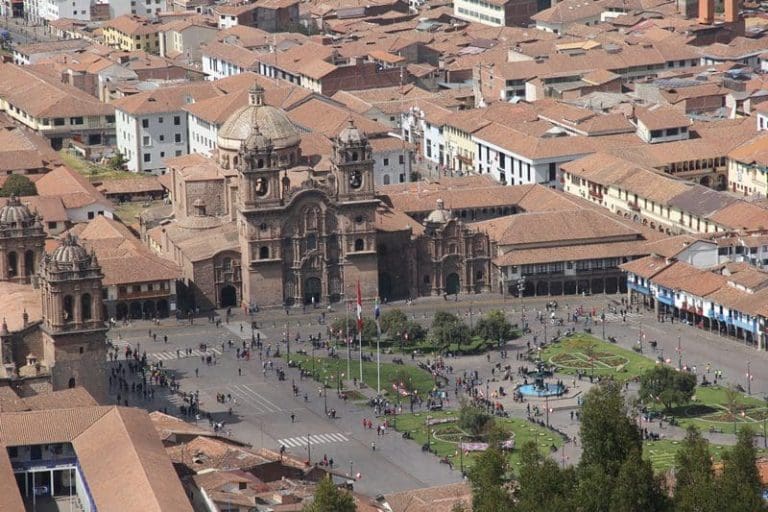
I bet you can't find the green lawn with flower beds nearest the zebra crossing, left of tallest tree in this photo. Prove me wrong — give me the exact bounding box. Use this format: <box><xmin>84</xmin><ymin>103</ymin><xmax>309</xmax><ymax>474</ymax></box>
<box><xmin>391</xmin><ymin>411</ymin><xmax>563</xmax><ymax>472</ymax></box>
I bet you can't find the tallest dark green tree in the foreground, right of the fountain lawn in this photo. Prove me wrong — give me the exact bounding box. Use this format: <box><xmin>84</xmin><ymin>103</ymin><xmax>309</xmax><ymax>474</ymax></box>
<box><xmin>580</xmin><ymin>381</ymin><xmax>643</xmax><ymax>475</ymax></box>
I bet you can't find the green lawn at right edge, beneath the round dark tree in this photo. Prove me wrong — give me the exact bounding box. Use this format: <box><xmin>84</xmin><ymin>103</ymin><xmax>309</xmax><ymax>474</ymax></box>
<box><xmin>652</xmin><ymin>386</ymin><xmax>768</xmax><ymax>434</ymax></box>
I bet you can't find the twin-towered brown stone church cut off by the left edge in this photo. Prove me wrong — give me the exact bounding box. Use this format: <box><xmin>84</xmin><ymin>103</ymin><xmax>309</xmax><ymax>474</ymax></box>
<box><xmin>0</xmin><ymin>197</ymin><xmax>107</xmax><ymax>402</ymax></box>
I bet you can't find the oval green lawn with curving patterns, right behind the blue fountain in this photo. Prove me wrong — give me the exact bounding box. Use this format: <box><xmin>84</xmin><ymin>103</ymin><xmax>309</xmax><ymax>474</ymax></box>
<box><xmin>540</xmin><ymin>333</ymin><xmax>656</xmax><ymax>381</ymax></box>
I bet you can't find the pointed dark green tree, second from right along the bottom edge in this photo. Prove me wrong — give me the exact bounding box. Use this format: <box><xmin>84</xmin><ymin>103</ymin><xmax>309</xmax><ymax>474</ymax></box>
<box><xmin>673</xmin><ymin>426</ymin><xmax>716</xmax><ymax>512</ymax></box>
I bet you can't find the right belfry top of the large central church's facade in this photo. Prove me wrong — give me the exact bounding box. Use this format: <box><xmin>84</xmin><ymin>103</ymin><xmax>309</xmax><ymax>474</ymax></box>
<box><xmin>331</xmin><ymin>119</ymin><xmax>374</xmax><ymax>200</ymax></box>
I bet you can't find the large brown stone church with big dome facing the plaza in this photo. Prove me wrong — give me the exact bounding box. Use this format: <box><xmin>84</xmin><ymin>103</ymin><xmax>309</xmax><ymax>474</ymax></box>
<box><xmin>146</xmin><ymin>86</ymin><xmax>493</xmax><ymax>309</ymax></box>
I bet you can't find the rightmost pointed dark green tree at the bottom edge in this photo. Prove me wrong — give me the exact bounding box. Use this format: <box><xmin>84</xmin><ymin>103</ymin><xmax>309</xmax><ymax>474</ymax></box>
<box><xmin>717</xmin><ymin>427</ymin><xmax>766</xmax><ymax>512</ymax></box>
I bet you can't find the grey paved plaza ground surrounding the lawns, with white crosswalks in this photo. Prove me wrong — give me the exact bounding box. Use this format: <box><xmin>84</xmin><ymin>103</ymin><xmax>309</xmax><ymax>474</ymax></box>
<box><xmin>109</xmin><ymin>295</ymin><xmax>768</xmax><ymax>495</ymax></box>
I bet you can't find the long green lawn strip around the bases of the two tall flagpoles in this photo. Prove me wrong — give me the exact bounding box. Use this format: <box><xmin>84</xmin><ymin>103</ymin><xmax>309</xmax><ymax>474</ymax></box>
<box><xmin>291</xmin><ymin>353</ymin><xmax>435</xmax><ymax>396</ymax></box>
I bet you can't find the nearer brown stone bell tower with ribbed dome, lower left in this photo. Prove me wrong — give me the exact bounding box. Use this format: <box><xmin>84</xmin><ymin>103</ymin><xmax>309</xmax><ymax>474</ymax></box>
<box><xmin>39</xmin><ymin>235</ymin><xmax>107</xmax><ymax>403</ymax></box>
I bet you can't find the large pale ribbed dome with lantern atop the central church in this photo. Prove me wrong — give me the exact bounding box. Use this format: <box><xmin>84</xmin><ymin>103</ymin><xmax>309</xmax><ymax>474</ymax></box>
<box><xmin>218</xmin><ymin>86</ymin><xmax>301</xmax><ymax>151</ymax></box>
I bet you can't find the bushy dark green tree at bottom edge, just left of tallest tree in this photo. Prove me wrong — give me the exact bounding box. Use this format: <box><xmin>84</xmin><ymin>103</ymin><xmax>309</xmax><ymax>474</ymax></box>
<box><xmin>515</xmin><ymin>441</ymin><xmax>576</xmax><ymax>512</ymax></box>
